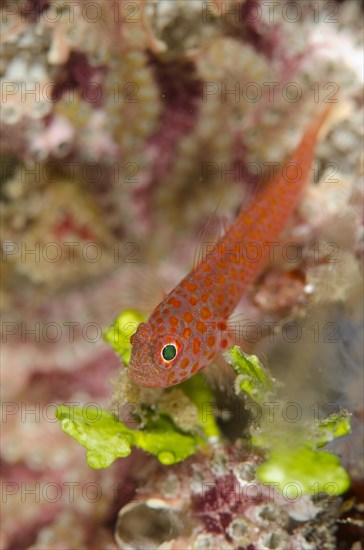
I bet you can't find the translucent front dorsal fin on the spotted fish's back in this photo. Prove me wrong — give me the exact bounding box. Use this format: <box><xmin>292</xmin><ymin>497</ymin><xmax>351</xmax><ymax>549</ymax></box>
<box><xmin>193</xmin><ymin>199</ymin><xmax>231</xmax><ymax>270</ymax></box>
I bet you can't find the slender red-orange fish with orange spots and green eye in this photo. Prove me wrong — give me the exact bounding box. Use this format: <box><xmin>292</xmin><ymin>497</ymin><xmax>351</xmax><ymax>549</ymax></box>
<box><xmin>129</xmin><ymin>109</ymin><xmax>329</xmax><ymax>388</ymax></box>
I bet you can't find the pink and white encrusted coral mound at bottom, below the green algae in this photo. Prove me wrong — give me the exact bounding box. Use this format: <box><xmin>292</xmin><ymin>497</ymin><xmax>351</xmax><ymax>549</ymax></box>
<box><xmin>116</xmin><ymin>446</ymin><xmax>337</xmax><ymax>550</ymax></box>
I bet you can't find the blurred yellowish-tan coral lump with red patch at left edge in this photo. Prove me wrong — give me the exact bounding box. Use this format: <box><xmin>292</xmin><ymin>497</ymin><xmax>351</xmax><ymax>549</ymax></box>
<box><xmin>3</xmin><ymin>164</ymin><xmax>114</xmax><ymax>291</ymax></box>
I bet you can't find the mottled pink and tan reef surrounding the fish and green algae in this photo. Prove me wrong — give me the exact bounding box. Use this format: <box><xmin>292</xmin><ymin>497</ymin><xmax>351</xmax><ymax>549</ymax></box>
<box><xmin>0</xmin><ymin>0</ymin><xmax>364</xmax><ymax>550</ymax></box>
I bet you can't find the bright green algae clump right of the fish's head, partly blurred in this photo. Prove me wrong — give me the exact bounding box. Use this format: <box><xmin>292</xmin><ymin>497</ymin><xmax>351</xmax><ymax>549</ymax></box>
<box><xmin>225</xmin><ymin>346</ymin><xmax>350</xmax><ymax>498</ymax></box>
